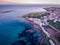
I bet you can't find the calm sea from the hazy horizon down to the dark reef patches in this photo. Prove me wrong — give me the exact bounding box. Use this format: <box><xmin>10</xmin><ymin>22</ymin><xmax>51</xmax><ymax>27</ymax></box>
<box><xmin>0</xmin><ymin>5</ymin><xmax>59</xmax><ymax>45</ymax></box>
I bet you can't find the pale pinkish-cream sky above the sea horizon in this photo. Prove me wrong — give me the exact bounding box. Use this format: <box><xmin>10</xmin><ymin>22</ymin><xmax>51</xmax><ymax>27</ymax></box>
<box><xmin>0</xmin><ymin>0</ymin><xmax>60</xmax><ymax>4</ymax></box>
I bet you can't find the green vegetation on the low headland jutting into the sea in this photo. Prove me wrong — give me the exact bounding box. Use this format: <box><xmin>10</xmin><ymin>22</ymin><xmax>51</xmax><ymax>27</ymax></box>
<box><xmin>22</xmin><ymin>12</ymin><xmax>49</xmax><ymax>18</ymax></box>
